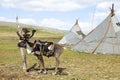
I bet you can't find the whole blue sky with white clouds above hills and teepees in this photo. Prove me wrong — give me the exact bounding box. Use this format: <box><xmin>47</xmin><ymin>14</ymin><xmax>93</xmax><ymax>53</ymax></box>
<box><xmin>0</xmin><ymin>0</ymin><xmax>120</xmax><ymax>32</ymax></box>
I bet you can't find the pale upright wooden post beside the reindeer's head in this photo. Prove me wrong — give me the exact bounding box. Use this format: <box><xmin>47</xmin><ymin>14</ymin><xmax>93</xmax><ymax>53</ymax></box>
<box><xmin>16</xmin><ymin>16</ymin><xmax>27</xmax><ymax>71</ymax></box>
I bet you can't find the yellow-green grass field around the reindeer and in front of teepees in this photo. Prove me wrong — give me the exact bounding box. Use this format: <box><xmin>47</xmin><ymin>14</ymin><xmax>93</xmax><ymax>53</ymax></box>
<box><xmin>0</xmin><ymin>26</ymin><xmax>120</xmax><ymax>80</ymax></box>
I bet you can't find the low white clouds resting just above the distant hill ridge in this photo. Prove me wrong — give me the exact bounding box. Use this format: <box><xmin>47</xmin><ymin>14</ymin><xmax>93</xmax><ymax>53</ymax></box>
<box><xmin>0</xmin><ymin>16</ymin><xmax>73</xmax><ymax>30</ymax></box>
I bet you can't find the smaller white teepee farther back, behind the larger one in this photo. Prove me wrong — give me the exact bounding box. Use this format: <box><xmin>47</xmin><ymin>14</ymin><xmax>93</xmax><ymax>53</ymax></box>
<box><xmin>58</xmin><ymin>20</ymin><xmax>85</xmax><ymax>45</ymax></box>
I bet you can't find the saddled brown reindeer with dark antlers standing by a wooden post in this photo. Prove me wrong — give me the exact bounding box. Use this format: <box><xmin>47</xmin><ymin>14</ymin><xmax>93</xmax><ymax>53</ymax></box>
<box><xmin>17</xmin><ymin>28</ymin><xmax>63</xmax><ymax>75</ymax></box>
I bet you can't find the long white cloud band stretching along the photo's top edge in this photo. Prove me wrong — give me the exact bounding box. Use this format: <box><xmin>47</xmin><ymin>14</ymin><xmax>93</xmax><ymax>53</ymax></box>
<box><xmin>0</xmin><ymin>0</ymin><xmax>120</xmax><ymax>11</ymax></box>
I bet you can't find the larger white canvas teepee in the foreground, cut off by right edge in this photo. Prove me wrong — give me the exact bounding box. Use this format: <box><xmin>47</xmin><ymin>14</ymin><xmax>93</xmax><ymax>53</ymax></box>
<box><xmin>72</xmin><ymin>5</ymin><xmax>120</xmax><ymax>54</ymax></box>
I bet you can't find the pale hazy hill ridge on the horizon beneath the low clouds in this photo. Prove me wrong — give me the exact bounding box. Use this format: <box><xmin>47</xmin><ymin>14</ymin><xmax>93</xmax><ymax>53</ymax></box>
<box><xmin>0</xmin><ymin>21</ymin><xmax>67</xmax><ymax>34</ymax></box>
